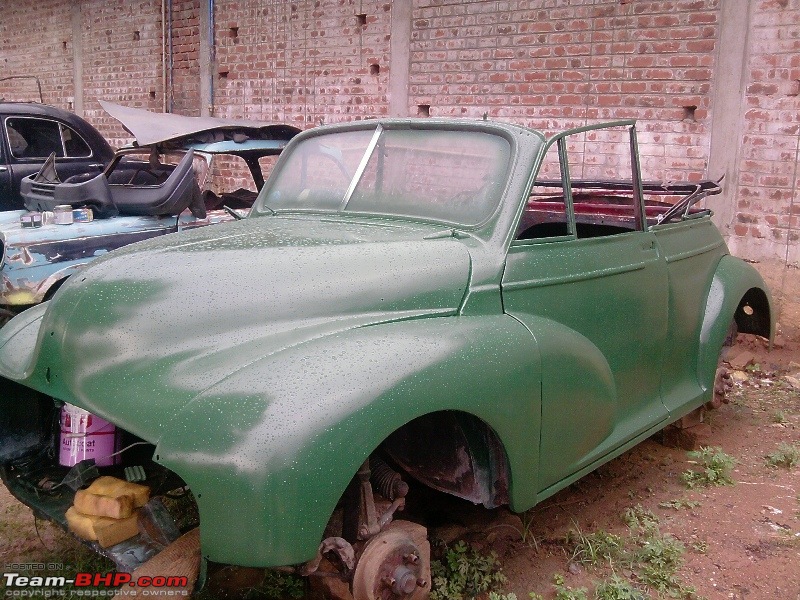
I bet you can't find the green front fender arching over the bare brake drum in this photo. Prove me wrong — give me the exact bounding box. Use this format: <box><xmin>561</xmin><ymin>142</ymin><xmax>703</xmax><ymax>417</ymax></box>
<box><xmin>156</xmin><ymin>315</ymin><xmax>541</xmax><ymax>566</ymax></box>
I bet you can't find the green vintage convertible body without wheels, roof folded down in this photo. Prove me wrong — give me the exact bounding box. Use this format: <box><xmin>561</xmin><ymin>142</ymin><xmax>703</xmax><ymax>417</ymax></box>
<box><xmin>0</xmin><ymin>120</ymin><xmax>773</xmax><ymax>588</ymax></box>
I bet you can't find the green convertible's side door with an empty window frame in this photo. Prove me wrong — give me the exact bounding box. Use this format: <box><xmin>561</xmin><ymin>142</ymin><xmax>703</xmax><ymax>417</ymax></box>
<box><xmin>502</xmin><ymin>123</ymin><xmax>669</xmax><ymax>497</ymax></box>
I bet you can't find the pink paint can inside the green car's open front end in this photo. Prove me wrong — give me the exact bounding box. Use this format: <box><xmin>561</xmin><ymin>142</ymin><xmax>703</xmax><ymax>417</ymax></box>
<box><xmin>58</xmin><ymin>404</ymin><xmax>119</xmax><ymax>467</ymax></box>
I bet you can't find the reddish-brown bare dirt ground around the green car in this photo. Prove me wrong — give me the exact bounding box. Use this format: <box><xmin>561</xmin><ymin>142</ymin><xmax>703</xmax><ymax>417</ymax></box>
<box><xmin>0</xmin><ymin>336</ymin><xmax>800</xmax><ymax>600</ymax></box>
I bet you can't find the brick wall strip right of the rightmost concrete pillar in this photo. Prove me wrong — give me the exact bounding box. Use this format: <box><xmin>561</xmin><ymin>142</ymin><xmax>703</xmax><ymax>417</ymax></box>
<box><xmin>731</xmin><ymin>0</ymin><xmax>800</xmax><ymax>268</ymax></box>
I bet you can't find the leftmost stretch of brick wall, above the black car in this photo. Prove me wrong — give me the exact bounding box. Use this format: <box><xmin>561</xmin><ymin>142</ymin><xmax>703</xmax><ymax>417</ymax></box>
<box><xmin>0</xmin><ymin>0</ymin><xmax>200</xmax><ymax>146</ymax></box>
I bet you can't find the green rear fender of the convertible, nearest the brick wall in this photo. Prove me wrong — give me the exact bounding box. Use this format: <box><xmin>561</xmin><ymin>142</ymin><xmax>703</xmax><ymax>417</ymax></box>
<box><xmin>697</xmin><ymin>255</ymin><xmax>775</xmax><ymax>392</ymax></box>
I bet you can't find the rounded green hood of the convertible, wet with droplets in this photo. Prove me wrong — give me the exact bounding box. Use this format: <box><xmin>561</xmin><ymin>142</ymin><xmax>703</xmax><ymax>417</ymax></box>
<box><xmin>0</xmin><ymin>216</ymin><xmax>470</xmax><ymax>442</ymax></box>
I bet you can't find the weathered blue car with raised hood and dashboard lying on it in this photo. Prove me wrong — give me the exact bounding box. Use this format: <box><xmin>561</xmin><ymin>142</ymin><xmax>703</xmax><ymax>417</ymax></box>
<box><xmin>0</xmin><ymin>103</ymin><xmax>300</xmax><ymax>322</ymax></box>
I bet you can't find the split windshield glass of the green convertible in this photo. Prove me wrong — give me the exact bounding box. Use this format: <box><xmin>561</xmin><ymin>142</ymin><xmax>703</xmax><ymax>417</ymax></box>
<box><xmin>256</xmin><ymin>126</ymin><xmax>511</xmax><ymax>226</ymax></box>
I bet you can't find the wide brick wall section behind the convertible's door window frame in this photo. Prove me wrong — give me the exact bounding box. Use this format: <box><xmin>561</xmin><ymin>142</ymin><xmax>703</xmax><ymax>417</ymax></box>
<box><xmin>410</xmin><ymin>0</ymin><xmax>718</xmax><ymax>179</ymax></box>
